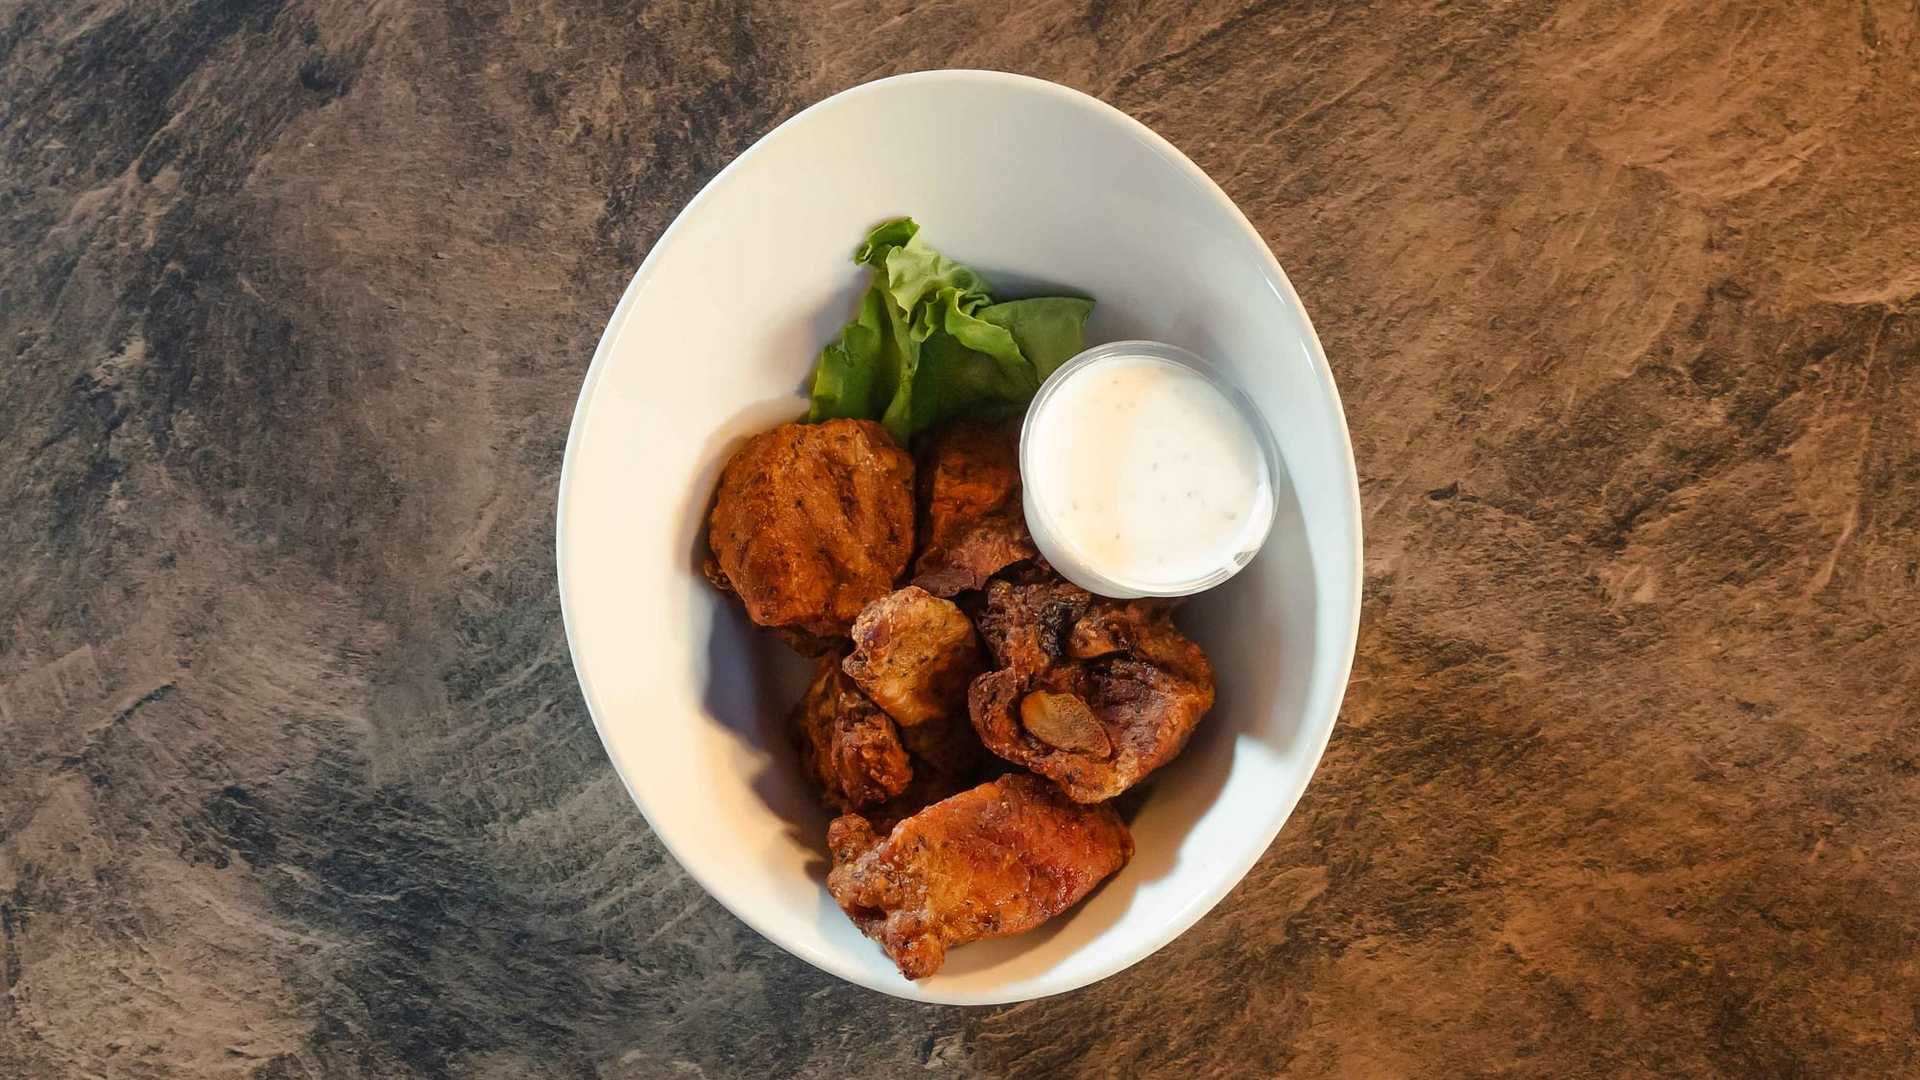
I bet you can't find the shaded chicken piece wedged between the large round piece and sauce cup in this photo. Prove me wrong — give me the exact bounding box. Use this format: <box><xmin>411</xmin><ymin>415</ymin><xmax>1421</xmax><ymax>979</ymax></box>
<box><xmin>914</xmin><ymin>417</ymin><xmax>1041</xmax><ymax>596</ymax></box>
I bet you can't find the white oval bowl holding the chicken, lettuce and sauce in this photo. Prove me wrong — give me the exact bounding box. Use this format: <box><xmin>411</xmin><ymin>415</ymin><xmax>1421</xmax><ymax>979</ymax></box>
<box><xmin>559</xmin><ymin>71</ymin><xmax>1361</xmax><ymax>1003</ymax></box>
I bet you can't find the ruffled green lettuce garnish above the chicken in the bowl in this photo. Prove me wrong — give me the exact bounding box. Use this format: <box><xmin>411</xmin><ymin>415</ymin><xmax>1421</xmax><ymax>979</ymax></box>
<box><xmin>806</xmin><ymin>217</ymin><xmax>1092</xmax><ymax>446</ymax></box>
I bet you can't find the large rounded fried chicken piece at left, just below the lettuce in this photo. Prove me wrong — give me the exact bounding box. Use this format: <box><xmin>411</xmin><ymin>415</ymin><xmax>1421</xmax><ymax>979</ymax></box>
<box><xmin>707</xmin><ymin>421</ymin><xmax>914</xmax><ymax>638</ymax></box>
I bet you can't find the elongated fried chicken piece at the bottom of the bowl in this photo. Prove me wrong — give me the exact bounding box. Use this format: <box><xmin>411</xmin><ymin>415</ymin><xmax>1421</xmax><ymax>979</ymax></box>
<box><xmin>828</xmin><ymin>773</ymin><xmax>1133</xmax><ymax>978</ymax></box>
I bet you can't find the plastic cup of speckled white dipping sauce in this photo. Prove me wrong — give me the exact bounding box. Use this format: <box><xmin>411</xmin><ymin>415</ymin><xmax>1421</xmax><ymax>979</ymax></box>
<box><xmin>1021</xmin><ymin>345</ymin><xmax>1273</xmax><ymax>596</ymax></box>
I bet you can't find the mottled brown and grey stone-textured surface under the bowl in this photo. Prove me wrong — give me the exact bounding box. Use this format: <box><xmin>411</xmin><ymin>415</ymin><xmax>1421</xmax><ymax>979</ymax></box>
<box><xmin>0</xmin><ymin>0</ymin><xmax>1920</xmax><ymax>1078</ymax></box>
